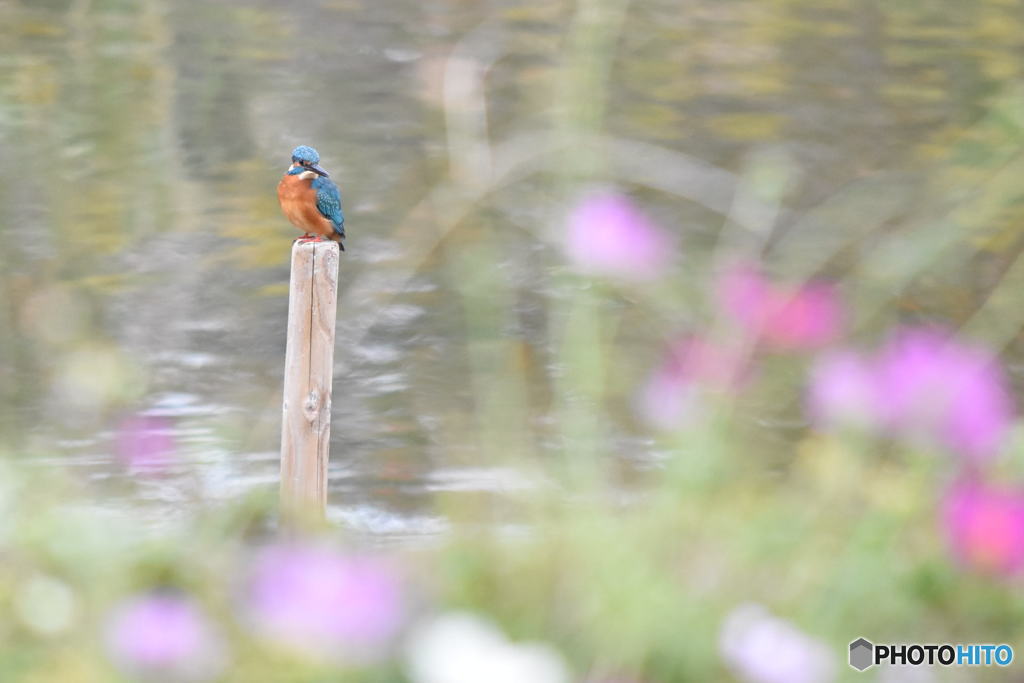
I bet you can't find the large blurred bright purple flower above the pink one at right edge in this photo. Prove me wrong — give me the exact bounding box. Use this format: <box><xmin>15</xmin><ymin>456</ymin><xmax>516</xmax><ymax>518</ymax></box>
<box><xmin>878</xmin><ymin>330</ymin><xmax>1014</xmax><ymax>460</ymax></box>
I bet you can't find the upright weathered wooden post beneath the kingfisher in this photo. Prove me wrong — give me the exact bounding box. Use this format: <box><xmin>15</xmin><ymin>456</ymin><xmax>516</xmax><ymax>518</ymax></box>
<box><xmin>281</xmin><ymin>242</ymin><xmax>339</xmax><ymax>521</ymax></box>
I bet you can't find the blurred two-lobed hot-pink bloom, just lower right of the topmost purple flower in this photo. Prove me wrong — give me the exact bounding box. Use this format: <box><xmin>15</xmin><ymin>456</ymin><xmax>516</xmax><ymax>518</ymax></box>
<box><xmin>718</xmin><ymin>265</ymin><xmax>843</xmax><ymax>351</ymax></box>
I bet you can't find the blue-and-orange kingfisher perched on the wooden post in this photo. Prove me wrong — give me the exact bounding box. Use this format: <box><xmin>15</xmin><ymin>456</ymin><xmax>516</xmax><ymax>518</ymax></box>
<box><xmin>278</xmin><ymin>144</ymin><xmax>345</xmax><ymax>251</ymax></box>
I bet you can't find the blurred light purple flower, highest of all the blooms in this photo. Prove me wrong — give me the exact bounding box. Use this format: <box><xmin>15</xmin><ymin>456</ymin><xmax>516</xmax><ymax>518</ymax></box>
<box><xmin>565</xmin><ymin>191</ymin><xmax>673</xmax><ymax>281</ymax></box>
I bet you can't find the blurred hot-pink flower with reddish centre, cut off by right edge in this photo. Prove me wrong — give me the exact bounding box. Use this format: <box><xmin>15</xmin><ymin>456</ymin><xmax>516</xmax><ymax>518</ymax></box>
<box><xmin>941</xmin><ymin>480</ymin><xmax>1024</xmax><ymax>574</ymax></box>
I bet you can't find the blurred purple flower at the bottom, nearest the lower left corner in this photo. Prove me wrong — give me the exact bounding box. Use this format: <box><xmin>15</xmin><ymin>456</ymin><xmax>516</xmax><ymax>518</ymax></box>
<box><xmin>106</xmin><ymin>593</ymin><xmax>224</xmax><ymax>681</ymax></box>
